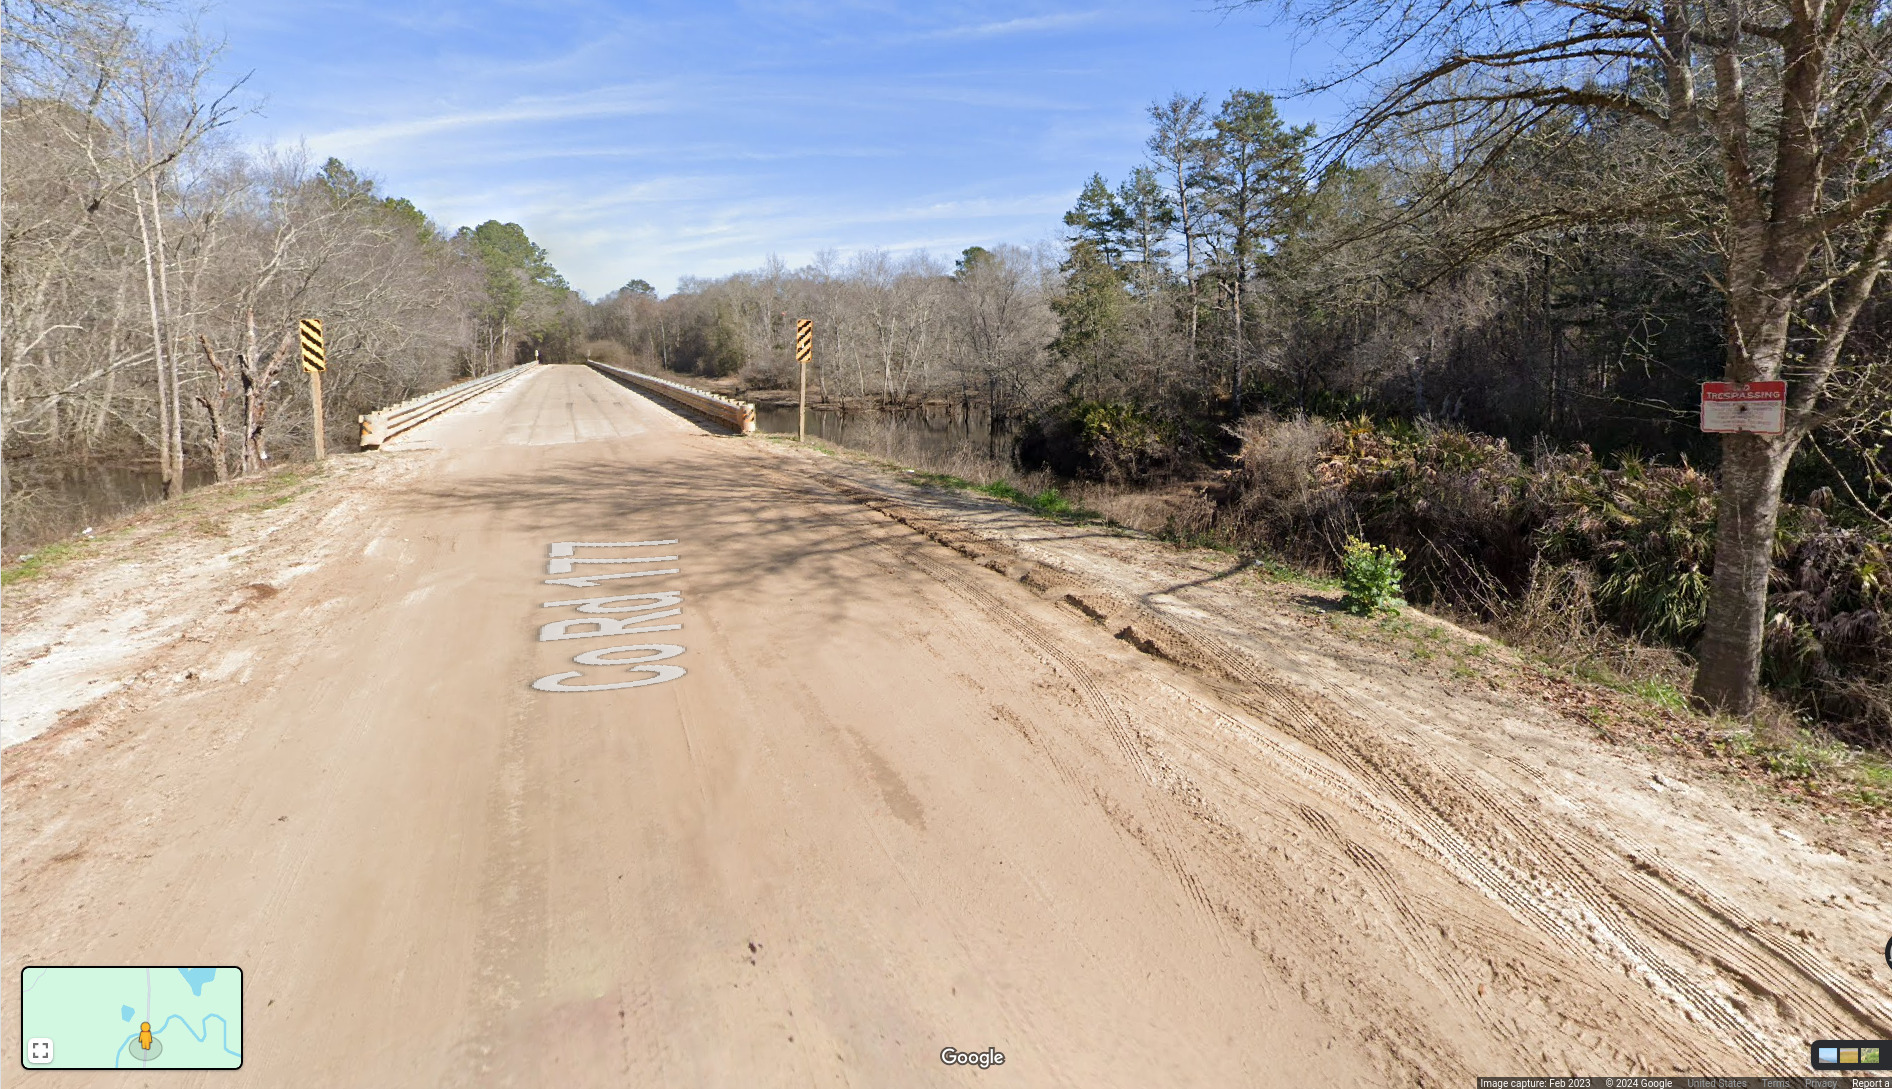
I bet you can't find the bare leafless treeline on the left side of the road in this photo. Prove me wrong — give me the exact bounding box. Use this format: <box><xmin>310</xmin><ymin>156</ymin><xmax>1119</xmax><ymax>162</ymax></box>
<box><xmin>0</xmin><ymin>0</ymin><xmax>583</xmax><ymax>533</ymax></box>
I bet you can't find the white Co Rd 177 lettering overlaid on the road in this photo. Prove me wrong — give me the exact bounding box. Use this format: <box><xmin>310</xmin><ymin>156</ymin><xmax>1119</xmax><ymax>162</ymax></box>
<box><xmin>532</xmin><ymin>541</ymin><xmax>685</xmax><ymax>692</ymax></box>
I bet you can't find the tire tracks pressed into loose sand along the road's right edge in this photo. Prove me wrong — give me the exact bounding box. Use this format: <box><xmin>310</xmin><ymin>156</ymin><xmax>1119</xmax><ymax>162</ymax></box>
<box><xmin>790</xmin><ymin>459</ymin><xmax>1888</xmax><ymax>1074</ymax></box>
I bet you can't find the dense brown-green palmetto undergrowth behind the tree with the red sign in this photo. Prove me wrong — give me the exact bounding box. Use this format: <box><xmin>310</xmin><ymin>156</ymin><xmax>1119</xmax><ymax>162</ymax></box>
<box><xmin>1203</xmin><ymin>416</ymin><xmax>1892</xmax><ymax>749</ymax></box>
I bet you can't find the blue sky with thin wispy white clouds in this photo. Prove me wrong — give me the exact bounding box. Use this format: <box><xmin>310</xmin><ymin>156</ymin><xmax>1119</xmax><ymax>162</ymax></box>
<box><xmin>201</xmin><ymin>0</ymin><xmax>1338</xmax><ymax>297</ymax></box>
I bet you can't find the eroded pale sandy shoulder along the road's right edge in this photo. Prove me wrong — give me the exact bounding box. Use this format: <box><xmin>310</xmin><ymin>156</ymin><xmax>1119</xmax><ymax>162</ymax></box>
<box><xmin>774</xmin><ymin>434</ymin><xmax>1892</xmax><ymax>1072</ymax></box>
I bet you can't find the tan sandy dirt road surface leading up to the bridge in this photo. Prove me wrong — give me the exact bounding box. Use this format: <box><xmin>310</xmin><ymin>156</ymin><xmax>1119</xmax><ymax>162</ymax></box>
<box><xmin>0</xmin><ymin>369</ymin><xmax>1886</xmax><ymax>1087</ymax></box>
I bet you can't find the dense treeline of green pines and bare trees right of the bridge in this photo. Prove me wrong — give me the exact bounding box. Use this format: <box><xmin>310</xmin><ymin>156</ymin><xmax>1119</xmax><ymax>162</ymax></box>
<box><xmin>588</xmin><ymin>91</ymin><xmax>1892</xmax><ymax>502</ymax></box>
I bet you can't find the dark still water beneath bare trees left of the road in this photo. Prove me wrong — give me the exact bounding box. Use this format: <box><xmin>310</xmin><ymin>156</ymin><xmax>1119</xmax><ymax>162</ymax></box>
<box><xmin>0</xmin><ymin>465</ymin><xmax>216</xmax><ymax>554</ymax></box>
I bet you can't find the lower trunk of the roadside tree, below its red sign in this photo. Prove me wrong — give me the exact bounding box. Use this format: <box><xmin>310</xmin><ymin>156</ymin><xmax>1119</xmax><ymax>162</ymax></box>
<box><xmin>1695</xmin><ymin>433</ymin><xmax>1797</xmax><ymax>717</ymax></box>
